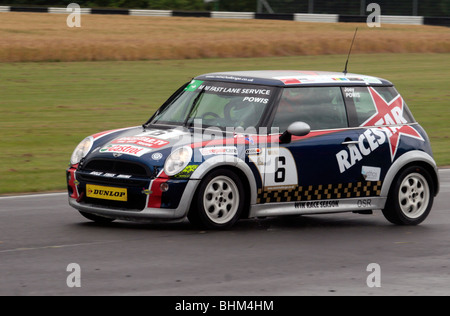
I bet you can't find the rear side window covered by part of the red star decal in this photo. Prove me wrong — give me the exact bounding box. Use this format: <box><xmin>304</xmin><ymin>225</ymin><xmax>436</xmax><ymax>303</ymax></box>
<box><xmin>343</xmin><ymin>87</ymin><xmax>414</xmax><ymax>126</ymax></box>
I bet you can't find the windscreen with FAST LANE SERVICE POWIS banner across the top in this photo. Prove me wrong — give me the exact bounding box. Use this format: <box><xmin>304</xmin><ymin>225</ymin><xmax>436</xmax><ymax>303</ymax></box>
<box><xmin>150</xmin><ymin>80</ymin><xmax>276</xmax><ymax>129</ymax></box>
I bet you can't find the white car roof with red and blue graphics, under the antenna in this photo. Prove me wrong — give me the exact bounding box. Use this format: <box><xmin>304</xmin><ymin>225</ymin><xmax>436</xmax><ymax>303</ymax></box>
<box><xmin>195</xmin><ymin>70</ymin><xmax>392</xmax><ymax>87</ymax></box>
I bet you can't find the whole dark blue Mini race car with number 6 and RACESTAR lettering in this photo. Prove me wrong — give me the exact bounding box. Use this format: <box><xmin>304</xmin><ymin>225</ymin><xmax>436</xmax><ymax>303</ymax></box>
<box><xmin>67</xmin><ymin>71</ymin><xmax>439</xmax><ymax>229</ymax></box>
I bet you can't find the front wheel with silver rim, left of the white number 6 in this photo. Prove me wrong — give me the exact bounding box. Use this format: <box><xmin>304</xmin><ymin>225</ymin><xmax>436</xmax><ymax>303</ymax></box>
<box><xmin>188</xmin><ymin>169</ymin><xmax>245</xmax><ymax>229</ymax></box>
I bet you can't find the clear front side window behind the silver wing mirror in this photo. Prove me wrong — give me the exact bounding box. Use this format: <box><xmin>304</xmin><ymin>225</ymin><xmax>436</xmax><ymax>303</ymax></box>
<box><xmin>272</xmin><ymin>87</ymin><xmax>348</xmax><ymax>132</ymax></box>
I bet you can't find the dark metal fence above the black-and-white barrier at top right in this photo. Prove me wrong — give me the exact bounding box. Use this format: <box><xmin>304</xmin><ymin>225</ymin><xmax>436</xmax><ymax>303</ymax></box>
<box><xmin>258</xmin><ymin>0</ymin><xmax>450</xmax><ymax>17</ymax></box>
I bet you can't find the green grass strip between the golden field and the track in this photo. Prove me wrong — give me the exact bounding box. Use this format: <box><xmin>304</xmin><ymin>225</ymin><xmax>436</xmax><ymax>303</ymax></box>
<box><xmin>0</xmin><ymin>54</ymin><xmax>450</xmax><ymax>194</ymax></box>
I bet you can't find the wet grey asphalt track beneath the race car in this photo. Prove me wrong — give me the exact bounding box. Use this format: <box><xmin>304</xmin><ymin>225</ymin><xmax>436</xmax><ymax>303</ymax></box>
<box><xmin>0</xmin><ymin>169</ymin><xmax>450</xmax><ymax>296</ymax></box>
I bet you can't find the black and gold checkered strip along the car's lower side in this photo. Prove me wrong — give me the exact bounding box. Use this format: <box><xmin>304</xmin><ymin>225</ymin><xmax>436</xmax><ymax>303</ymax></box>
<box><xmin>257</xmin><ymin>181</ymin><xmax>381</xmax><ymax>204</ymax></box>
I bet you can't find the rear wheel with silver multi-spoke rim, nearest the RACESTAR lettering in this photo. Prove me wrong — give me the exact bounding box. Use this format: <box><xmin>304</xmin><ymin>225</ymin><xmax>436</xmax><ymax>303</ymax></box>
<box><xmin>383</xmin><ymin>166</ymin><xmax>434</xmax><ymax>225</ymax></box>
